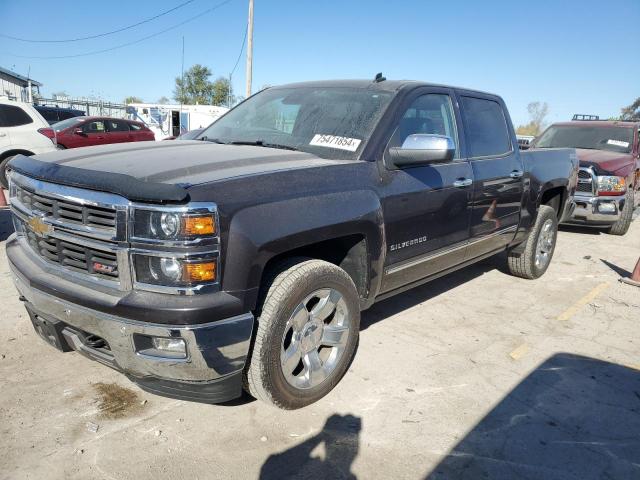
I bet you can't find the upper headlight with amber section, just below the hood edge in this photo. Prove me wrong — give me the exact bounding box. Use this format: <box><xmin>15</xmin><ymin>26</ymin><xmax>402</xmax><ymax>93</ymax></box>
<box><xmin>133</xmin><ymin>208</ymin><xmax>217</xmax><ymax>241</ymax></box>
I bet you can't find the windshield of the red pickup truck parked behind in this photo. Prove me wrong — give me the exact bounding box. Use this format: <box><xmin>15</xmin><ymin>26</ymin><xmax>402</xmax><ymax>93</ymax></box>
<box><xmin>536</xmin><ymin>125</ymin><xmax>633</xmax><ymax>153</ymax></box>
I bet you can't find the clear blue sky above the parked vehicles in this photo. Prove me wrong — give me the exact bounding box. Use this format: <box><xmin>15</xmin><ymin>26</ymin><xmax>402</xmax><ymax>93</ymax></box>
<box><xmin>0</xmin><ymin>0</ymin><xmax>640</xmax><ymax>125</ymax></box>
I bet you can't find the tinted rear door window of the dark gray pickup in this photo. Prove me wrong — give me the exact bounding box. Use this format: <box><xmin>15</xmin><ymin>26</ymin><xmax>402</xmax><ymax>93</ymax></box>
<box><xmin>462</xmin><ymin>97</ymin><xmax>511</xmax><ymax>157</ymax></box>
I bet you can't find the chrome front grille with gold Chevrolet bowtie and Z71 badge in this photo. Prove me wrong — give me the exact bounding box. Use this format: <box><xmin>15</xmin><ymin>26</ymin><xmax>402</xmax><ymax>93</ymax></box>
<box><xmin>9</xmin><ymin>172</ymin><xmax>131</xmax><ymax>290</ymax></box>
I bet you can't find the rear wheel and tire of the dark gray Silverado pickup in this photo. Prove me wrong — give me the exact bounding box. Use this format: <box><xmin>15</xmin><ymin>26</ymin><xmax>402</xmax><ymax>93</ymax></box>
<box><xmin>508</xmin><ymin>205</ymin><xmax>558</xmax><ymax>280</ymax></box>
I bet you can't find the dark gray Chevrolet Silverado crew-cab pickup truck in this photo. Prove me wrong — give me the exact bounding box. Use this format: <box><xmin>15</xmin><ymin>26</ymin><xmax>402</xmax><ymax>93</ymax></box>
<box><xmin>7</xmin><ymin>77</ymin><xmax>578</xmax><ymax>409</ymax></box>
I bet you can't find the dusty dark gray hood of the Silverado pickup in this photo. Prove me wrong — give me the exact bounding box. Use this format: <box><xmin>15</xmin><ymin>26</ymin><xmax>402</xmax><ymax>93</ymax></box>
<box><xmin>34</xmin><ymin>140</ymin><xmax>343</xmax><ymax>187</ymax></box>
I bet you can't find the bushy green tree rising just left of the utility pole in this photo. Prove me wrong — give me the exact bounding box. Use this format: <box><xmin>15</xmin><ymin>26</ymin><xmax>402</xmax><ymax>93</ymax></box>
<box><xmin>173</xmin><ymin>64</ymin><xmax>230</xmax><ymax>105</ymax></box>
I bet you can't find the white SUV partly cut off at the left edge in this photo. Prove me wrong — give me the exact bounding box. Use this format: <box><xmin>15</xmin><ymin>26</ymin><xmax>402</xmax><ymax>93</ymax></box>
<box><xmin>0</xmin><ymin>98</ymin><xmax>56</xmax><ymax>188</ymax></box>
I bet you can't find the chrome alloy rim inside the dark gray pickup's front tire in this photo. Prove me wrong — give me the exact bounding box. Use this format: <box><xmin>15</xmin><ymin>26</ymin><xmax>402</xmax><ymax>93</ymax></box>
<box><xmin>280</xmin><ymin>288</ymin><xmax>351</xmax><ymax>389</ymax></box>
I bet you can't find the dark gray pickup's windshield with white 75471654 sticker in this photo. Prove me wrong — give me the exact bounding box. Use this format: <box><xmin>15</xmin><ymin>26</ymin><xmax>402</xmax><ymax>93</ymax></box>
<box><xmin>200</xmin><ymin>87</ymin><xmax>392</xmax><ymax>160</ymax></box>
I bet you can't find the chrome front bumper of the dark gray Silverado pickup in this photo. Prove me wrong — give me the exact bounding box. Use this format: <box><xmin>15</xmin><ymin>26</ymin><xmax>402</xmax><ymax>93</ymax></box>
<box><xmin>9</xmin><ymin>234</ymin><xmax>253</xmax><ymax>403</ymax></box>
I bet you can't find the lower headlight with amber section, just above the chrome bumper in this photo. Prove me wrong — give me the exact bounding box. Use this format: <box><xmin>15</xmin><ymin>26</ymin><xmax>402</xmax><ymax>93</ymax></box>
<box><xmin>133</xmin><ymin>254</ymin><xmax>218</xmax><ymax>288</ymax></box>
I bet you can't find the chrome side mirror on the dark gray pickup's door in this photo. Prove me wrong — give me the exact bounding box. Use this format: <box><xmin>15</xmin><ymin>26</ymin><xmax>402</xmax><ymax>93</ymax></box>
<box><xmin>389</xmin><ymin>133</ymin><xmax>456</xmax><ymax>168</ymax></box>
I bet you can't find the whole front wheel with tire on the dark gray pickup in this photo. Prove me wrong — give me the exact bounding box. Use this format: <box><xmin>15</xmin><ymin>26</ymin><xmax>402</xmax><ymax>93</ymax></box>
<box><xmin>244</xmin><ymin>259</ymin><xmax>360</xmax><ymax>410</ymax></box>
